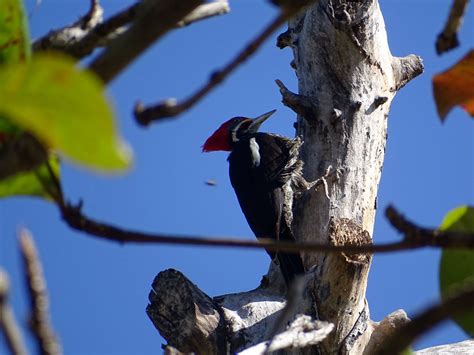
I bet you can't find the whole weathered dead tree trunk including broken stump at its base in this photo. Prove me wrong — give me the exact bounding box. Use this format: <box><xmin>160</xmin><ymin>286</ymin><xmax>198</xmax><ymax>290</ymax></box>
<box><xmin>147</xmin><ymin>0</ymin><xmax>423</xmax><ymax>354</ymax></box>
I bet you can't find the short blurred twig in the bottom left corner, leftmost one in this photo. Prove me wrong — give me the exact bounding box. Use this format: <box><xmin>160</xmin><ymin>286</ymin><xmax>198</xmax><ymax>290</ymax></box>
<box><xmin>0</xmin><ymin>268</ymin><xmax>27</xmax><ymax>355</ymax></box>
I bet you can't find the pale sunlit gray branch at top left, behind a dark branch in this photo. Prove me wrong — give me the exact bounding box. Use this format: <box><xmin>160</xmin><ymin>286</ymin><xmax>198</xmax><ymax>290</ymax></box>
<box><xmin>33</xmin><ymin>0</ymin><xmax>230</xmax><ymax>59</ymax></box>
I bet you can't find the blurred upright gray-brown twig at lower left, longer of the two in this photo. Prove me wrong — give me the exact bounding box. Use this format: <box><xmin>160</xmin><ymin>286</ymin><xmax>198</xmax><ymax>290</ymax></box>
<box><xmin>19</xmin><ymin>229</ymin><xmax>62</xmax><ymax>355</ymax></box>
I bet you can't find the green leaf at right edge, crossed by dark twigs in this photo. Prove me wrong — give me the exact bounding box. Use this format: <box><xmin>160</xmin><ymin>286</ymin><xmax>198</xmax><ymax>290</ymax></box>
<box><xmin>439</xmin><ymin>206</ymin><xmax>474</xmax><ymax>336</ymax></box>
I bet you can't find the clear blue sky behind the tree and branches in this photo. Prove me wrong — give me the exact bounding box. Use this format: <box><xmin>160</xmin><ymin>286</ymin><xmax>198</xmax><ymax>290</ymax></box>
<box><xmin>0</xmin><ymin>0</ymin><xmax>474</xmax><ymax>354</ymax></box>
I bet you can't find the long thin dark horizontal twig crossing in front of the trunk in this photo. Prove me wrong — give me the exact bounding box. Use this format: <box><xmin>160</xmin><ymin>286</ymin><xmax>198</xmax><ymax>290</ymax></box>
<box><xmin>39</xmin><ymin>166</ymin><xmax>474</xmax><ymax>254</ymax></box>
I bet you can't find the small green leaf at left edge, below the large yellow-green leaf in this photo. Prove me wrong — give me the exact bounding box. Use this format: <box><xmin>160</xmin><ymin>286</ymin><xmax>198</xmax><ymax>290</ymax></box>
<box><xmin>0</xmin><ymin>155</ymin><xmax>59</xmax><ymax>200</ymax></box>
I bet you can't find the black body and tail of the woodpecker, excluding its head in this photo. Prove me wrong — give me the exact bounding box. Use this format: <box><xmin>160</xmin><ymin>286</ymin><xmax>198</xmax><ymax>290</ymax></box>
<box><xmin>229</xmin><ymin>133</ymin><xmax>304</xmax><ymax>283</ymax></box>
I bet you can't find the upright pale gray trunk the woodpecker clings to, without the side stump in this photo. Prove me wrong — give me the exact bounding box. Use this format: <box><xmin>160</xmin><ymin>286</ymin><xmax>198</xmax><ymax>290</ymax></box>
<box><xmin>282</xmin><ymin>0</ymin><xmax>422</xmax><ymax>353</ymax></box>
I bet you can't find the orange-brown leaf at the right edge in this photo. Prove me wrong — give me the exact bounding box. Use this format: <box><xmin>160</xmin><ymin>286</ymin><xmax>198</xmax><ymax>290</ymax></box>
<box><xmin>433</xmin><ymin>50</ymin><xmax>474</xmax><ymax>121</ymax></box>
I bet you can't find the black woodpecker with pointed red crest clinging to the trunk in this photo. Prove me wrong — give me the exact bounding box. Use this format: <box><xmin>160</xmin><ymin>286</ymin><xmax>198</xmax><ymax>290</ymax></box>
<box><xmin>202</xmin><ymin>110</ymin><xmax>311</xmax><ymax>285</ymax></box>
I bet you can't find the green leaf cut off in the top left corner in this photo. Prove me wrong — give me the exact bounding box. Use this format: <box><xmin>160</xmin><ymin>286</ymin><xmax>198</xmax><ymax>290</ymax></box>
<box><xmin>0</xmin><ymin>0</ymin><xmax>31</xmax><ymax>64</ymax></box>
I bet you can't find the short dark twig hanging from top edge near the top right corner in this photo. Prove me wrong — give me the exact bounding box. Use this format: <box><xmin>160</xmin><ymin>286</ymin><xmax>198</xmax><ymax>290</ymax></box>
<box><xmin>436</xmin><ymin>0</ymin><xmax>469</xmax><ymax>55</ymax></box>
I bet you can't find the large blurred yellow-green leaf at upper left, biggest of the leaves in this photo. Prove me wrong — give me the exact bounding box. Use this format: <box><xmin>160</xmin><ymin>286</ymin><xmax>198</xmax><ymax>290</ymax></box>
<box><xmin>0</xmin><ymin>53</ymin><xmax>131</xmax><ymax>171</ymax></box>
